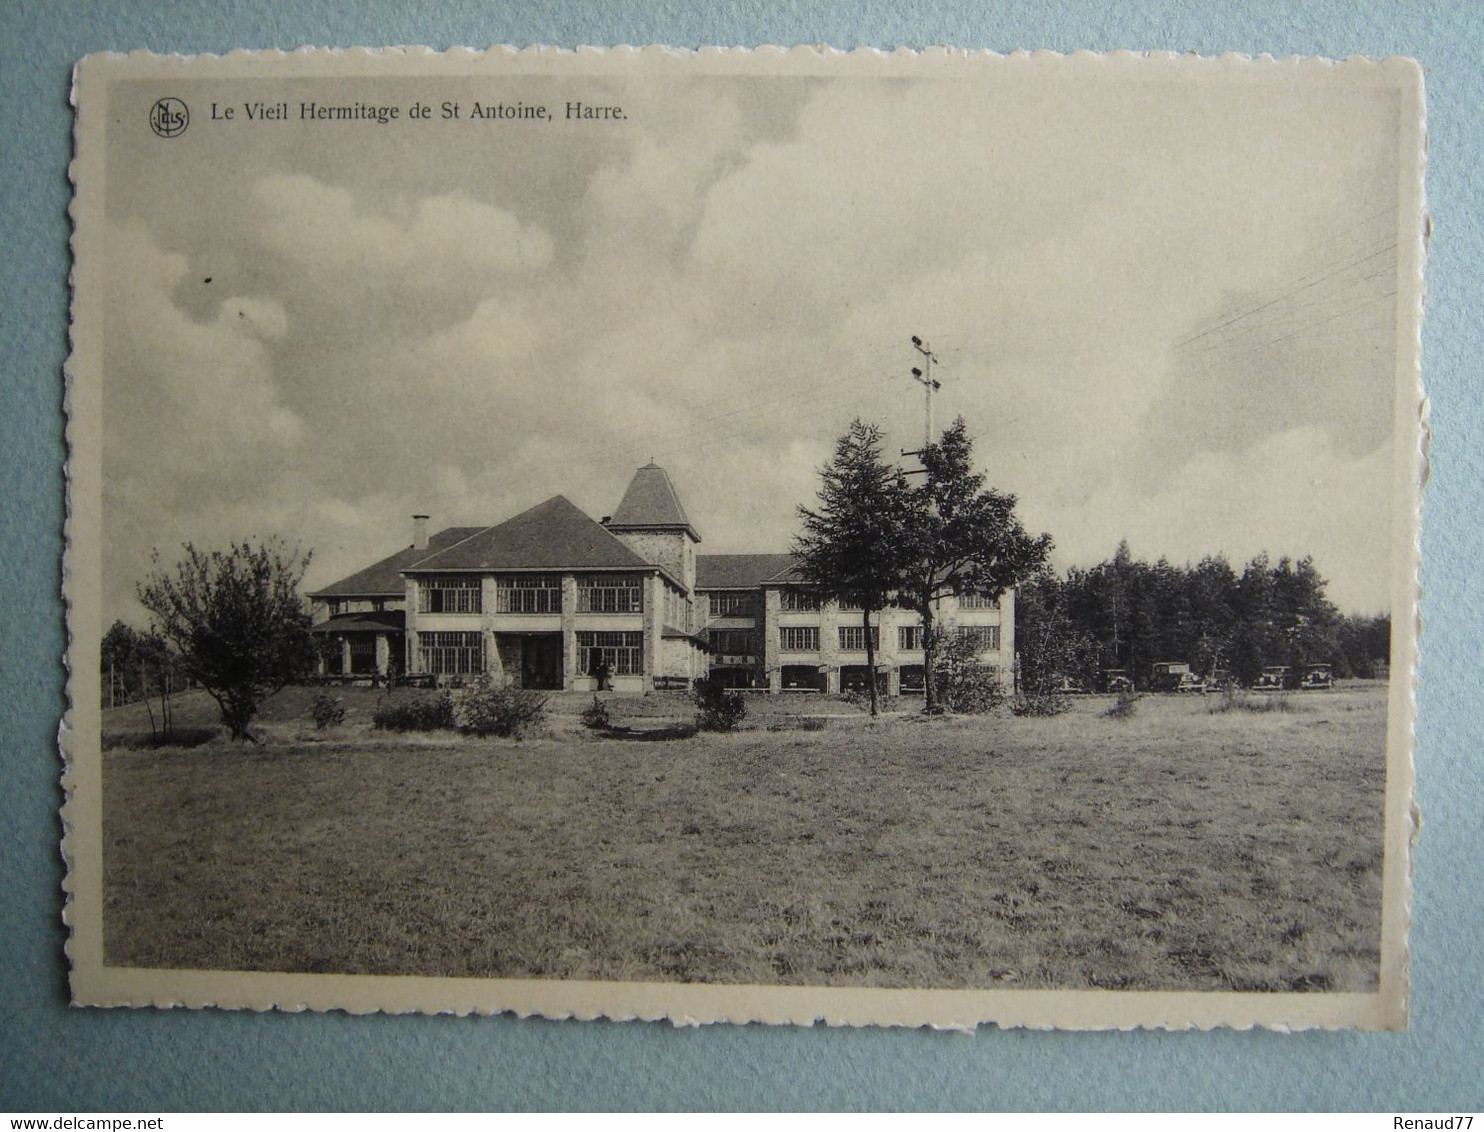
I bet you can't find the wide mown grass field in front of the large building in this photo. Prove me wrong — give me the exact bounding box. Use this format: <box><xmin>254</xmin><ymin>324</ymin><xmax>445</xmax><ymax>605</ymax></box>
<box><xmin>104</xmin><ymin>687</ymin><xmax>1386</xmax><ymax>991</ymax></box>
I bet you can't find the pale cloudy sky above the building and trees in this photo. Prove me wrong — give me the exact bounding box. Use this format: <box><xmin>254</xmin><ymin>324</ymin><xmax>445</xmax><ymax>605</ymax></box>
<box><xmin>104</xmin><ymin>60</ymin><xmax>1398</xmax><ymax>622</ymax></box>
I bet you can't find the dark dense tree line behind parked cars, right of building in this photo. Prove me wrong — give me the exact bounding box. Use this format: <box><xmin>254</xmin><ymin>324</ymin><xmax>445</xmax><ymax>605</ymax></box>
<box><xmin>1015</xmin><ymin>542</ymin><xmax>1391</xmax><ymax>688</ymax></box>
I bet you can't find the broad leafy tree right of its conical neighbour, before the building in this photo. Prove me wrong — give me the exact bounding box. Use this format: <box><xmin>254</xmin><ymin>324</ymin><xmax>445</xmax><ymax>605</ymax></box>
<box><xmin>899</xmin><ymin>417</ymin><xmax>1051</xmax><ymax>712</ymax></box>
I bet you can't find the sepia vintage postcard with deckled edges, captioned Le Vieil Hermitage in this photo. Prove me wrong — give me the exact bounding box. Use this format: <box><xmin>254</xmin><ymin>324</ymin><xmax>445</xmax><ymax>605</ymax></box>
<box><xmin>61</xmin><ymin>47</ymin><xmax>1426</xmax><ymax>1030</ymax></box>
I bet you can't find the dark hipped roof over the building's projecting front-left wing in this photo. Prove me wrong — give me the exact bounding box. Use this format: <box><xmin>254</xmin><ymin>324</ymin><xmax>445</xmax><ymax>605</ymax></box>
<box><xmin>402</xmin><ymin>496</ymin><xmax>656</xmax><ymax>573</ymax></box>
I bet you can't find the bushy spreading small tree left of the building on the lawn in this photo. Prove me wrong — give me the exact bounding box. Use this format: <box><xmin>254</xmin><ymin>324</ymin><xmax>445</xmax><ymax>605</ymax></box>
<box><xmin>138</xmin><ymin>540</ymin><xmax>315</xmax><ymax>739</ymax></box>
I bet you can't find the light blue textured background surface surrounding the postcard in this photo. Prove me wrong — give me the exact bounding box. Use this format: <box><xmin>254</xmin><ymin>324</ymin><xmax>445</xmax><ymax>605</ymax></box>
<box><xmin>0</xmin><ymin>0</ymin><xmax>1484</xmax><ymax>1113</ymax></box>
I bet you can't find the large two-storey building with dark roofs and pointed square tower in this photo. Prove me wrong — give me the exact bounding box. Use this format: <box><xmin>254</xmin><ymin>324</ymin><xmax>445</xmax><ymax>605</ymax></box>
<box><xmin>310</xmin><ymin>463</ymin><xmax>1015</xmax><ymax>694</ymax></box>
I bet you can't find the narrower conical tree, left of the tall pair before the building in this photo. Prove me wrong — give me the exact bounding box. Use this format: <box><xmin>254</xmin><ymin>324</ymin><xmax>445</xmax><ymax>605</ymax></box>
<box><xmin>794</xmin><ymin>420</ymin><xmax>907</xmax><ymax>715</ymax></box>
